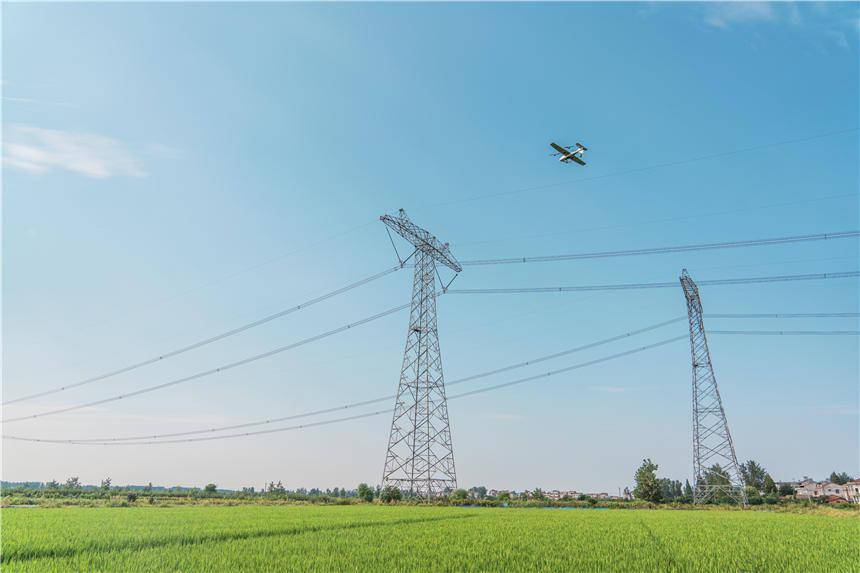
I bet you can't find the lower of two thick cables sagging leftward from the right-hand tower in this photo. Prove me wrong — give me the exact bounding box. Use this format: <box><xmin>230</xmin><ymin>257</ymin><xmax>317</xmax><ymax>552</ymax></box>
<box><xmin>3</xmin><ymin>336</ymin><xmax>687</xmax><ymax>446</ymax></box>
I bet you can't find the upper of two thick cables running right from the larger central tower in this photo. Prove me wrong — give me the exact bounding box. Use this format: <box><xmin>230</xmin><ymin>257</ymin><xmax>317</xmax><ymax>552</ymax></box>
<box><xmin>461</xmin><ymin>231</ymin><xmax>860</xmax><ymax>266</ymax></box>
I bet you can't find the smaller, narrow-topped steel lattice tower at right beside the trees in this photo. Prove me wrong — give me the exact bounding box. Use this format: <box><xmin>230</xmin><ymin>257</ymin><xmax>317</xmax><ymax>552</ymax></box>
<box><xmin>681</xmin><ymin>269</ymin><xmax>747</xmax><ymax>505</ymax></box>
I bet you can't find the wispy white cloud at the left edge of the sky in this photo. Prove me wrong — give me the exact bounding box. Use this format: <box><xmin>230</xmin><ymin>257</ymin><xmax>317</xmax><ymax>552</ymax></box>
<box><xmin>3</xmin><ymin>125</ymin><xmax>146</xmax><ymax>179</ymax></box>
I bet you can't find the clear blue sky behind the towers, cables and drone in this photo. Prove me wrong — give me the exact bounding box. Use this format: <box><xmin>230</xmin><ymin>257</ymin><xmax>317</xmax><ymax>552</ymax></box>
<box><xmin>2</xmin><ymin>4</ymin><xmax>860</xmax><ymax>492</ymax></box>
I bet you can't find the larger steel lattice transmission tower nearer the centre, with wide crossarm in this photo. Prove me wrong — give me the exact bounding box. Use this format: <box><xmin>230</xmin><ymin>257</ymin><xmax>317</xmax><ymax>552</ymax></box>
<box><xmin>380</xmin><ymin>209</ymin><xmax>462</xmax><ymax>499</ymax></box>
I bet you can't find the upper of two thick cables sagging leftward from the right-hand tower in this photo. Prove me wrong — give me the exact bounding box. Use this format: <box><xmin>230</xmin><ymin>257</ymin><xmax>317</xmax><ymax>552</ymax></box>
<box><xmin>11</xmin><ymin>316</ymin><xmax>685</xmax><ymax>442</ymax></box>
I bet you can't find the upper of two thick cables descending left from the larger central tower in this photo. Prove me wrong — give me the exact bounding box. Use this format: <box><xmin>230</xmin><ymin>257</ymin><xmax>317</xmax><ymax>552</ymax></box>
<box><xmin>3</xmin><ymin>266</ymin><xmax>400</xmax><ymax>404</ymax></box>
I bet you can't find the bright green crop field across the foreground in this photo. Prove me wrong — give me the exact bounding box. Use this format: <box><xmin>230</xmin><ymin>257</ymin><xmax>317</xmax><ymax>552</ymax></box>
<box><xmin>2</xmin><ymin>505</ymin><xmax>860</xmax><ymax>573</ymax></box>
